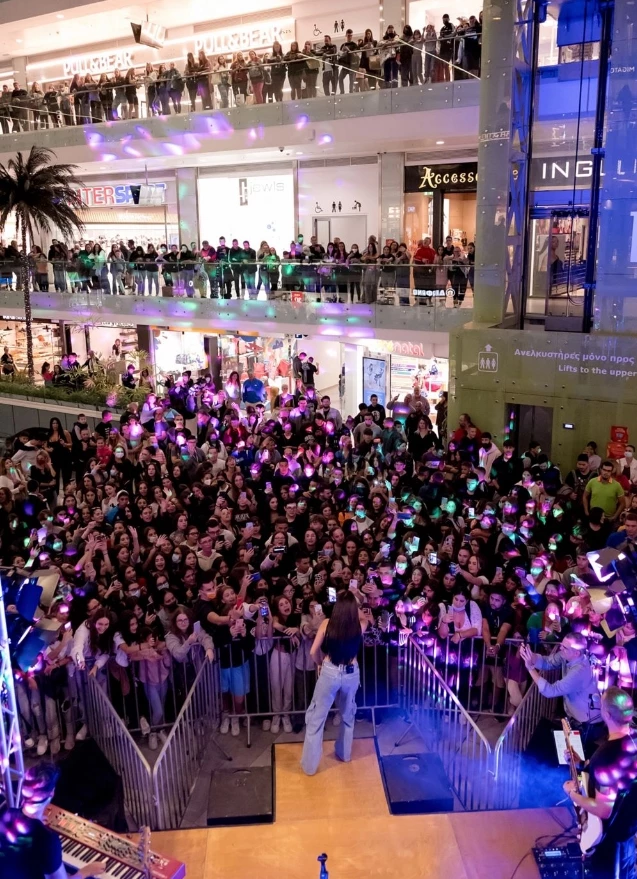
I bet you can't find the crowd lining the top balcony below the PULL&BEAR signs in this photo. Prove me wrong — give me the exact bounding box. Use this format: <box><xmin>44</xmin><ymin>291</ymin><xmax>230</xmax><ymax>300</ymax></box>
<box><xmin>0</xmin><ymin>13</ymin><xmax>482</xmax><ymax>134</ymax></box>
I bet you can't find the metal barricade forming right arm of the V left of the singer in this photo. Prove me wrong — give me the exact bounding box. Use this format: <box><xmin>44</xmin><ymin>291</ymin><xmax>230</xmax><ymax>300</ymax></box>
<box><xmin>152</xmin><ymin>662</ymin><xmax>220</xmax><ymax>830</ymax></box>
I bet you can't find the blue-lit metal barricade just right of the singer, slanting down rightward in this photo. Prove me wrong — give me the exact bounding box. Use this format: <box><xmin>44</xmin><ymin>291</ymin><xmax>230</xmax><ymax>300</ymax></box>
<box><xmin>405</xmin><ymin>637</ymin><xmax>494</xmax><ymax>811</ymax></box>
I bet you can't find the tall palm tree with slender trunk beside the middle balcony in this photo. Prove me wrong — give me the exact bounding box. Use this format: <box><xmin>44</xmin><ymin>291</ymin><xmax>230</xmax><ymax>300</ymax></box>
<box><xmin>0</xmin><ymin>146</ymin><xmax>84</xmax><ymax>381</ymax></box>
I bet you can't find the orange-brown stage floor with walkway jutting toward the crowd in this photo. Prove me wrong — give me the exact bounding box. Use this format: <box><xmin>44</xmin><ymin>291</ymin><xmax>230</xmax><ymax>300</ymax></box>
<box><xmin>153</xmin><ymin>739</ymin><xmax>572</xmax><ymax>879</ymax></box>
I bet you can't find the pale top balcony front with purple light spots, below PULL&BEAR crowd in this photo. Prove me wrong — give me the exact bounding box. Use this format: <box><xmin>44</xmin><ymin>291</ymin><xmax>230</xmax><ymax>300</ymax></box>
<box><xmin>0</xmin><ymin>71</ymin><xmax>480</xmax><ymax>165</ymax></box>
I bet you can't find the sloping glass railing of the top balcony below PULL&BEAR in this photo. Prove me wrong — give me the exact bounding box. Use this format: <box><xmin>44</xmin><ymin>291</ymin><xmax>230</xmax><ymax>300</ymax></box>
<box><xmin>0</xmin><ymin>35</ymin><xmax>480</xmax><ymax>134</ymax></box>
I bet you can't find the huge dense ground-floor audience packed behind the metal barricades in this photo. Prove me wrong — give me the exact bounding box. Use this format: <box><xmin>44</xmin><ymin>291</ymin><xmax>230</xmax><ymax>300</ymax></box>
<box><xmin>0</xmin><ymin>362</ymin><xmax>637</xmax><ymax>754</ymax></box>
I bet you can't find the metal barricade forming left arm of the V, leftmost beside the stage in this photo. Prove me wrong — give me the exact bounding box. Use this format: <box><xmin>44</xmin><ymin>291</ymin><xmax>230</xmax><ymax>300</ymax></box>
<box><xmin>77</xmin><ymin>672</ymin><xmax>157</xmax><ymax>829</ymax></box>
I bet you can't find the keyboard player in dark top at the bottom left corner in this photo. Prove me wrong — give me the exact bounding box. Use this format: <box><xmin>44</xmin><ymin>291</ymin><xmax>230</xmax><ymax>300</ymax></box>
<box><xmin>0</xmin><ymin>763</ymin><xmax>106</xmax><ymax>879</ymax></box>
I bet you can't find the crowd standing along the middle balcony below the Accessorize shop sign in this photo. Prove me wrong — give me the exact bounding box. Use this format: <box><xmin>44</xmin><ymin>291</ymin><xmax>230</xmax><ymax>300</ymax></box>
<box><xmin>0</xmin><ymin>235</ymin><xmax>476</xmax><ymax>305</ymax></box>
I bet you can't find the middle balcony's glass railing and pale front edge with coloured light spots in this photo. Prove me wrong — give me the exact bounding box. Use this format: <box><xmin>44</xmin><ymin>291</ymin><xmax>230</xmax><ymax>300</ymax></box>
<box><xmin>0</xmin><ymin>263</ymin><xmax>473</xmax><ymax>341</ymax></box>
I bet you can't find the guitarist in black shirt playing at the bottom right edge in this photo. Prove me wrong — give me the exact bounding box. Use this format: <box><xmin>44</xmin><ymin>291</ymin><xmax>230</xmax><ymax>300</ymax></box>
<box><xmin>564</xmin><ymin>687</ymin><xmax>637</xmax><ymax>879</ymax></box>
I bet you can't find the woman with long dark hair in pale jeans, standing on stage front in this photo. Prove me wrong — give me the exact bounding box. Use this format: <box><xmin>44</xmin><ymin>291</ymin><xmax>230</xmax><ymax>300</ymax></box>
<box><xmin>301</xmin><ymin>591</ymin><xmax>367</xmax><ymax>775</ymax></box>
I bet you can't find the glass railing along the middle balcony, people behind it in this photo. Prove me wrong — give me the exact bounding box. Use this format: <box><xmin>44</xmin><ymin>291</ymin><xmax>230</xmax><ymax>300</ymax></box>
<box><xmin>0</xmin><ymin>260</ymin><xmax>473</xmax><ymax>307</ymax></box>
